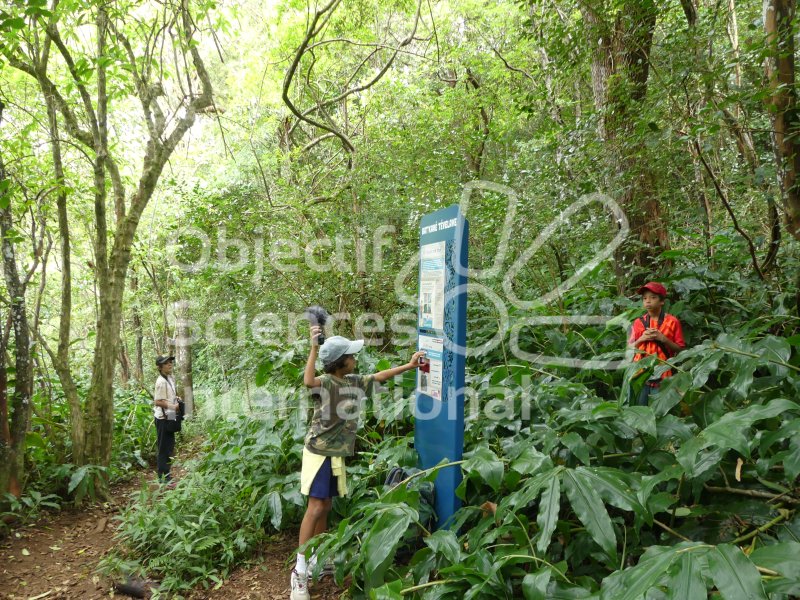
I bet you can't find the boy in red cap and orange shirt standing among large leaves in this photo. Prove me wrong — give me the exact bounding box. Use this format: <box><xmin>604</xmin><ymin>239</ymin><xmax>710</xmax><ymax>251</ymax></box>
<box><xmin>628</xmin><ymin>281</ymin><xmax>686</xmax><ymax>406</ymax></box>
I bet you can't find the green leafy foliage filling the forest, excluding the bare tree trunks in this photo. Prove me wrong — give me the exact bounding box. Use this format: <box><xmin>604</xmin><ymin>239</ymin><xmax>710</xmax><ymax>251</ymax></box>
<box><xmin>0</xmin><ymin>0</ymin><xmax>800</xmax><ymax>600</ymax></box>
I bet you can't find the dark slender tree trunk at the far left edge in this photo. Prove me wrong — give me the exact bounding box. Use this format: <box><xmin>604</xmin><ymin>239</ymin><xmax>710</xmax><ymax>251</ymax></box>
<box><xmin>0</xmin><ymin>103</ymin><xmax>33</xmax><ymax>496</ymax></box>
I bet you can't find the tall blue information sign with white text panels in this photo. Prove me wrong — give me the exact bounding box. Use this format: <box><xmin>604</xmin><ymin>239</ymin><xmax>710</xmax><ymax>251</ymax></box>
<box><xmin>414</xmin><ymin>205</ymin><xmax>469</xmax><ymax>528</ymax></box>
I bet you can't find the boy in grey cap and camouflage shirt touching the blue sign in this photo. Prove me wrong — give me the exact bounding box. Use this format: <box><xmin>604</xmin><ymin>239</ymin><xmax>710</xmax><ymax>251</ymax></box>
<box><xmin>291</xmin><ymin>325</ymin><xmax>425</xmax><ymax>600</ymax></box>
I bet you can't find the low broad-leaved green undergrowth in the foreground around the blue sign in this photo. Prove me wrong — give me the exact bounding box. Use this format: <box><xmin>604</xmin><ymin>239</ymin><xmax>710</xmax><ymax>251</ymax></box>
<box><xmin>106</xmin><ymin>274</ymin><xmax>800</xmax><ymax>599</ymax></box>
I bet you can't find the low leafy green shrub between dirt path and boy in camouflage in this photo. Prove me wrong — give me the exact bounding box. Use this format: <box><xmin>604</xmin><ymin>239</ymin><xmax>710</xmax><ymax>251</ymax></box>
<box><xmin>105</xmin><ymin>417</ymin><xmax>304</xmax><ymax>590</ymax></box>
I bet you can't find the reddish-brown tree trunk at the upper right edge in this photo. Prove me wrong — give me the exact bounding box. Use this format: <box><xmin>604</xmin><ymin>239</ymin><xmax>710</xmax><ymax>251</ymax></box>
<box><xmin>764</xmin><ymin>0</ymin><xmax>800</xmax><ymax>240</ymax></box>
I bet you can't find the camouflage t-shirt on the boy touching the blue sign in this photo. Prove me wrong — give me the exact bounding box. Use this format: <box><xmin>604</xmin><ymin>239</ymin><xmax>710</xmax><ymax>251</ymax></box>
<box><xmin>306</xmin><ymin>373</ymin><xmax>375</xmax><ymax>456</ymax></box>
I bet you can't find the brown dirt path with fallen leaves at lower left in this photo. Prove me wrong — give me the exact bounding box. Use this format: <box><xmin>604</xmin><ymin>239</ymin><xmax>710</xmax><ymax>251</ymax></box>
<box><xmin>0</xmin><ymin>478</ymin><xmax>341</xmax><ymax>600</ymax></box>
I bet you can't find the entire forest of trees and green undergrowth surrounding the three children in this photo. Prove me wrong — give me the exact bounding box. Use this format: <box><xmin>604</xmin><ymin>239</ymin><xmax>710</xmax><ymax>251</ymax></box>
<box><xmin>0</xmin><ymin>0</ymin><xmax>800</xmax><ymax>600</ymax></box>
